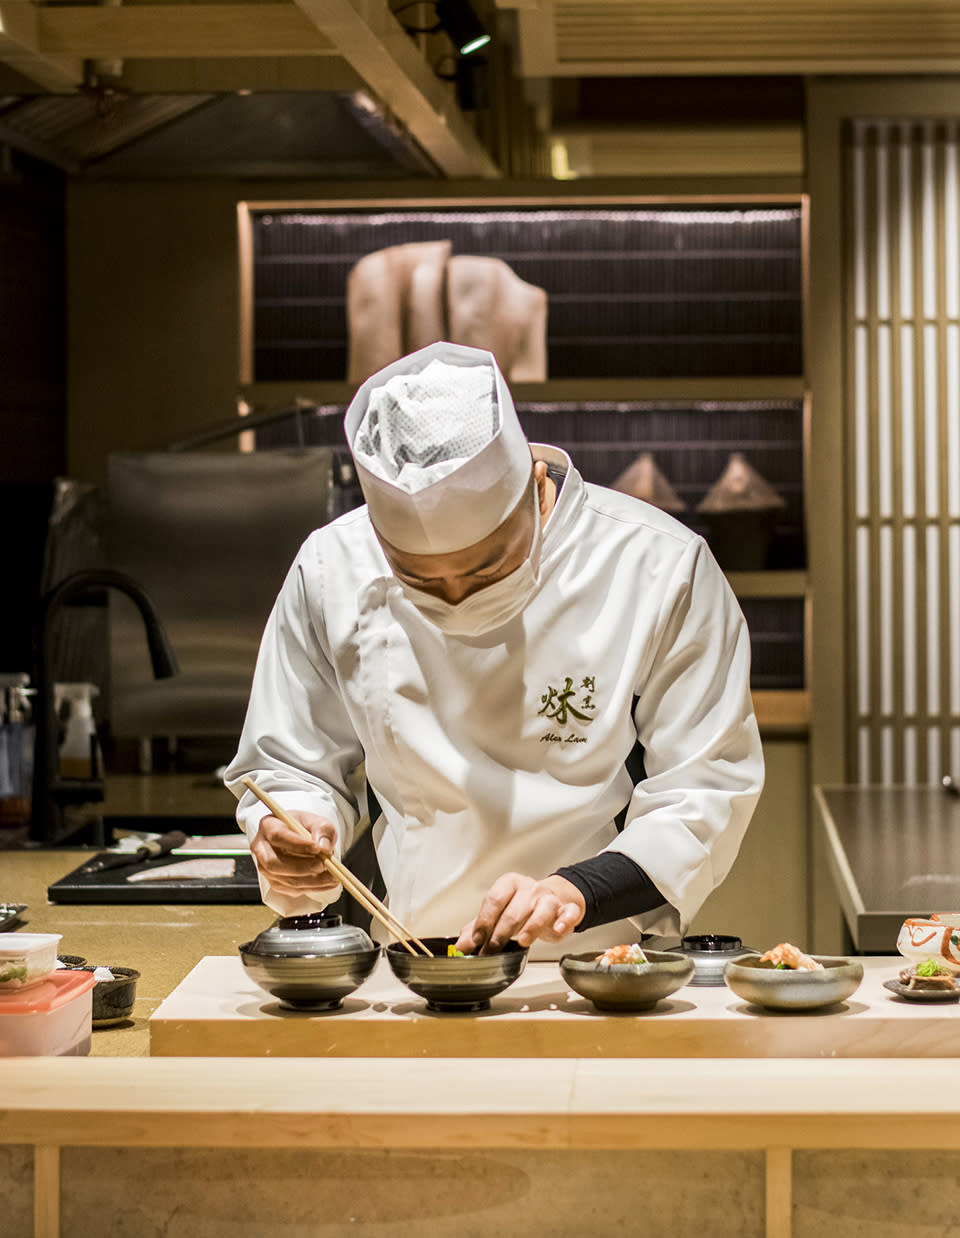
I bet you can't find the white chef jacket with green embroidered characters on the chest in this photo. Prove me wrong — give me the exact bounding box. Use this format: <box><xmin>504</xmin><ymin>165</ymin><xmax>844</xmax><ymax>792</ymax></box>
<box><xmin>225</xmin><ymin>444</ymin><xmax>763</xmax><ymax>957</ymax></box>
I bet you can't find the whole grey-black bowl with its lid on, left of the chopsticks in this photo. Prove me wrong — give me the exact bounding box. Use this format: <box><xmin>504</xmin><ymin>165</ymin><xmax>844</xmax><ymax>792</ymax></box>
<box><xmin>239</xmin><ymin>912</ymin><xmax>380</xmax><ymax>1010</ymax></box>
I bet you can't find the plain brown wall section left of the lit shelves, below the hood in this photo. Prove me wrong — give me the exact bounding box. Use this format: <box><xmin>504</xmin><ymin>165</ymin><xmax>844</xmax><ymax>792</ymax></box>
<box><xmin>67</xmin><ymin>182</ymin><xmax>244</xmax><ymax>482</ymax></box>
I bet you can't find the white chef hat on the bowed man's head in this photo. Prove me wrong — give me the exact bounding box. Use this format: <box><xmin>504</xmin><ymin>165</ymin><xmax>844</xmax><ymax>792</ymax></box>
<box><xmin>344</xmin><ymin>342</ymin><xmax>533</xmax><ymax>555</ymax></box>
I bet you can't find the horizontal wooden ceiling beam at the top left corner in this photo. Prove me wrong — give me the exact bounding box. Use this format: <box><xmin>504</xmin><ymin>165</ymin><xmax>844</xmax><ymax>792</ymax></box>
<box><xmin>34</xmin><ymin>4</ymin><xmax>337</xmax><ymax>59</ymax></box>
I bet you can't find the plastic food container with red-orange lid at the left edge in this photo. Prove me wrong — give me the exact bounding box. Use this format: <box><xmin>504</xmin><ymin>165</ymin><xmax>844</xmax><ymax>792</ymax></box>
<box><xmin>0</xmin><ymin>968</ymin><xmax>97</xmax><ymax>1057</ymax></box>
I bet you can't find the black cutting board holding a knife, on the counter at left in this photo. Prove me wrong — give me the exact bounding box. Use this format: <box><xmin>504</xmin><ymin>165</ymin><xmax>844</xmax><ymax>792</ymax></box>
<box><xmin>47</xmin><ymin>853</ymin><xmax>263</xmax><ymax>904</ymax></box>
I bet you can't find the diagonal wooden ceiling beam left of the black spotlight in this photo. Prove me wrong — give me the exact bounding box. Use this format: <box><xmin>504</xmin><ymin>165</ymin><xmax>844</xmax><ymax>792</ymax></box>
<box><xmin>284</xmin><ymin>0</ymin><xmax>508</xmax><ymax>178</ymax></box>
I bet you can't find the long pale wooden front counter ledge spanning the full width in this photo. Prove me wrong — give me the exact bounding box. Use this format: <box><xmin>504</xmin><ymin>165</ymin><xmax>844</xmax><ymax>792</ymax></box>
<box><xmin>0</xmin><ymin>1058</ymin><xmax>960</xmax><ymax>1150</ymax></box>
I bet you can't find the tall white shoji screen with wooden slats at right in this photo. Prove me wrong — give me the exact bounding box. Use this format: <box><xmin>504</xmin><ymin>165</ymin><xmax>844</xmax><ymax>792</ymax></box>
<box><xmin>845</xmin><ymin>120</ymin><xmax>960</xmax><ymax>782</ymax></box>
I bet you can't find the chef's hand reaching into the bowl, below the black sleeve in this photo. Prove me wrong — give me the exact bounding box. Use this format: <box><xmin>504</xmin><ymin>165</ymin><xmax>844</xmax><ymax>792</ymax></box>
<box><xmin>457</xmin><ymin>873</ymin><xmax>587</xmax><ymax>954</ymax></box>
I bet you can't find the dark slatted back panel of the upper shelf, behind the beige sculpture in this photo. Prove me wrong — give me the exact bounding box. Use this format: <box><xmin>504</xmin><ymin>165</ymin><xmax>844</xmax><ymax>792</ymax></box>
<box><xmin>253</xmin><ymin>208</ymin><xmax>803</xmax><ymax>383</ymax></box>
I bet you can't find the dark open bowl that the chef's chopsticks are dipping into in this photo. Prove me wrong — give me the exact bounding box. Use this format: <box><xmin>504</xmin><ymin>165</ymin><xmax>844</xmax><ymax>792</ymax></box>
<box><xmin>386</xmin><ymin>937</ymin><xmax>528</xmax><ymax>1014</ymax></box>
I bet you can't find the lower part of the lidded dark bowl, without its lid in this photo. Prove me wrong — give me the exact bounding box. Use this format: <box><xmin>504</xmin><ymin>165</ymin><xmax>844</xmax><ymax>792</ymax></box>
<box><xmin>240</xmin><ymin>941</ymin><xmax>380</xmax><ymax>1010</ymax></box>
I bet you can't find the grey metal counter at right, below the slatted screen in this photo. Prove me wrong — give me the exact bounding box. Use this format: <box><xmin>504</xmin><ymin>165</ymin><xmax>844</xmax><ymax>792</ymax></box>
<box><xmin>814</xmin><ymin>786</ymin><xmax>960</xmax><ymax>954</ymax></box>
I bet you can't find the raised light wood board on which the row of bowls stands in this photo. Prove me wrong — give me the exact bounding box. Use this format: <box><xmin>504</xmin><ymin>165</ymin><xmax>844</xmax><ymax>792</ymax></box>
<box><xmin>150</xmin><ymin>953</ymin><xmax>960</xmax><ymax>1058</ymax></box>
